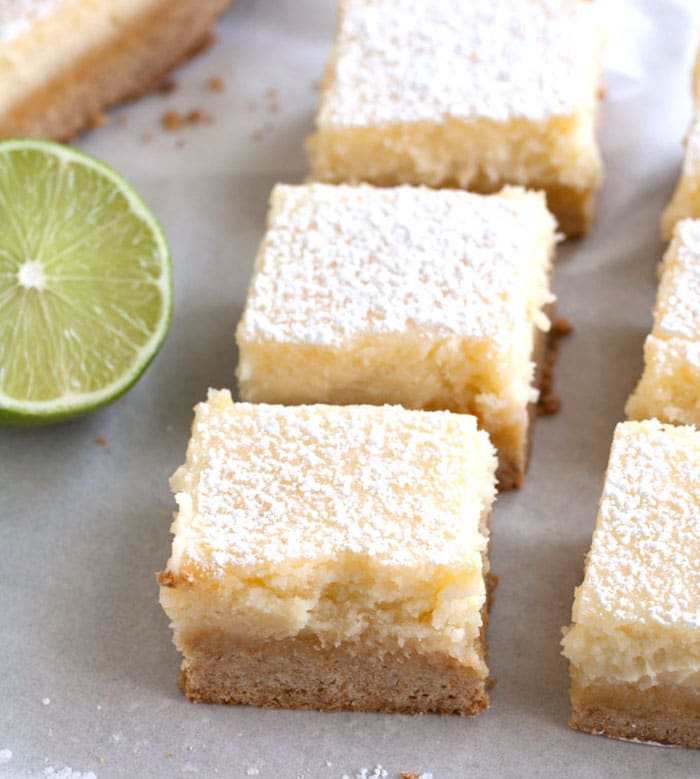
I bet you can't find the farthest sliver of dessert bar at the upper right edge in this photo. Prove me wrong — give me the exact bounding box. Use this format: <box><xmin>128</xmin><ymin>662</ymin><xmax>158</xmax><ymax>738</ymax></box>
<box><xmin>661</xmin><ymin>49</ymin><xmax>700</xmax><ymax>241</ymax></box>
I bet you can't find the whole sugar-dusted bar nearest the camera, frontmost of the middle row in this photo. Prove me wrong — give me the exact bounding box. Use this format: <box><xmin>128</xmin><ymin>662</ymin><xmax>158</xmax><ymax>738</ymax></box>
<box><xmin>159</xmin><ymin>390</ymin><xmax>496</xmax><ymax>714</ymax></box>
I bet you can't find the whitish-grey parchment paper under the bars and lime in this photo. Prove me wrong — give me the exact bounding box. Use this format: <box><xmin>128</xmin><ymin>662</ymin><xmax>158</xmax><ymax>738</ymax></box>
<box><xmin>0</xmin><ymin>0</ymin><xmax>700</xmax><ymax>779</ymax></box>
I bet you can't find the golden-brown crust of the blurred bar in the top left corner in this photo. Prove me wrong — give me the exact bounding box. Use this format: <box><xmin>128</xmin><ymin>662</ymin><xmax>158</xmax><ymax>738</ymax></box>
<box><xmin>0</xmin><ymin>0</ymin><xmax>232</xmax><ymax>141</ymax></box>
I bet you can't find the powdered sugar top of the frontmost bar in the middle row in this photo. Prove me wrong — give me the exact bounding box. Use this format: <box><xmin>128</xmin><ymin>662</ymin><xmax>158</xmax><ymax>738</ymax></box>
<box><xmin>172</xmin><ymin>391</ymin><xmax>496</xmax><ymax>576</ymax></box>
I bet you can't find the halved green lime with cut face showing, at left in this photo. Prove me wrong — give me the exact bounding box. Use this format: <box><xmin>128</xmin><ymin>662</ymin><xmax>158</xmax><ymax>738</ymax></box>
<box><xmin>0</xmin><ymin>139</ymin><xmax>172</xmax><ymax>424</ymax></box>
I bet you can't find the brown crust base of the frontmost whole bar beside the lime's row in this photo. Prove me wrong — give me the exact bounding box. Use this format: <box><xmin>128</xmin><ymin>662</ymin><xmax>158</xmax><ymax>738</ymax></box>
<box><xmin>161</xmin><ymin>570</ymin><xmax>498</xmax><ymax>715</ymax></box>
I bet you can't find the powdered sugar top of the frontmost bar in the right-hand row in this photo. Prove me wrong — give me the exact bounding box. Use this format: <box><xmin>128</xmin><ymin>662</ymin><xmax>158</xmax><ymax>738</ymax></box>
<box><xmin>578</xmin><ymin>420</ymin><xmax>700</xmax><ymax>629</ymax></box>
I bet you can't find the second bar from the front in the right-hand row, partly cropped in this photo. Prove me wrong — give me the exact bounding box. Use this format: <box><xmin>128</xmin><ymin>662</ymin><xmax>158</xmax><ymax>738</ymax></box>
<box><xmin>626</xmin><ymin>219</ymin><xmax>700</xmax><ymax>427</ymax></box>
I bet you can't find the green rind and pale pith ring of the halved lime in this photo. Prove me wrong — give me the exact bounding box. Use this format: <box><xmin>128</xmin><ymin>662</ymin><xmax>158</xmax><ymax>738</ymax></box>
<box><xmin>0</xmin><ymin>139</ymin><xmax>173</xmax><ymax>425</ymax></box>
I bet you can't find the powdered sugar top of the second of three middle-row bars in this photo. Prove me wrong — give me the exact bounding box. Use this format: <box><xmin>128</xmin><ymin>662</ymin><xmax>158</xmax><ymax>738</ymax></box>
<box><xmin>239</xmin><ymin>184</ymin><xmax>554</xmax><ymax>350</ymax></box>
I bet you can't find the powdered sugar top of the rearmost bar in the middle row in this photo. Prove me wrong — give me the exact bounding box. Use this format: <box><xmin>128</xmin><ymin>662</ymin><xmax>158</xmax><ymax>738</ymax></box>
<box><xmin>319</xmin><ymin>0</ymin><xmax>602</xmax><ymax>127</ymax></box>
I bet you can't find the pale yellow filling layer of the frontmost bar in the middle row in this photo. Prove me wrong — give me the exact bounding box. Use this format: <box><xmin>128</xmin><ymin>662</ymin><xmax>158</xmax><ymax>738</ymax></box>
<box><xmin>161</xmin><ymin>540</ymin><xmax>486</xmax><ymax>671</ymax></box>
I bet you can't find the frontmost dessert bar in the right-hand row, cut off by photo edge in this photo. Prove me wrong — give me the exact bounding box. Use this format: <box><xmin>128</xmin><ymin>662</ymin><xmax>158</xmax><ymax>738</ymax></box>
<box><xmin>563</xmin><ymin>420</ymin><xmax>700</xmax><ymax>747</ymax></box>
